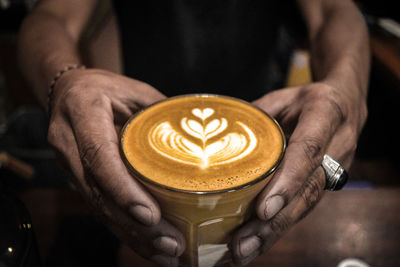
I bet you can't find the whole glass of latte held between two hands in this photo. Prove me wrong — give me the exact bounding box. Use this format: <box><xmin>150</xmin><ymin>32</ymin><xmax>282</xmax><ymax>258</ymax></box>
<box><xmin>121</xmin><ymin>95</ymin><xmax>285</xmax><ymax>267</ymax></box>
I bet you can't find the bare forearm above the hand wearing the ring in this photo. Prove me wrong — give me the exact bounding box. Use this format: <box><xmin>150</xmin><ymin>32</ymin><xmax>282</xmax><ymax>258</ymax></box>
<box><xmin>300</xmin><ymin>1</ymin><xmax>370</xmax><ymax>99</ymax></box>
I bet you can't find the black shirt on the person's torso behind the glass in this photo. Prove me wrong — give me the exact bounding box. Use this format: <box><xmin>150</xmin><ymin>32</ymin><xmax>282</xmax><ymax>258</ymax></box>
<box><xmin>114</xmin><ymin>0</ymin><xmax>303</xmax><ymax>101</ymax></box>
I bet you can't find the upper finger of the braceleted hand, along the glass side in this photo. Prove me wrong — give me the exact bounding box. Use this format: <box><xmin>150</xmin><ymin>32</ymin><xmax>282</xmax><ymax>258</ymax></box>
<box><xmin>68</xmin><ymin>96</ymin><xmax>161</xmax><ymax>225</ymax></box>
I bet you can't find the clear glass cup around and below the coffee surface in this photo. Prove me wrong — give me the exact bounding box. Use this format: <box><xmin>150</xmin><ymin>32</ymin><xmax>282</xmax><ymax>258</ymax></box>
<box><xmin>121</xmin><ymin>95</ymin><xmax>286</xmax><ymax>267</ymax></box>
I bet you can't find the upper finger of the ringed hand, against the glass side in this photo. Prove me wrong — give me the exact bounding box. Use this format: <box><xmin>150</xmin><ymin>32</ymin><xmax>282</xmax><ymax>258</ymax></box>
<box><xmin>256</xmin><ymin>98</ymin><xmax>342</xmax><ymax>220</ymax></box>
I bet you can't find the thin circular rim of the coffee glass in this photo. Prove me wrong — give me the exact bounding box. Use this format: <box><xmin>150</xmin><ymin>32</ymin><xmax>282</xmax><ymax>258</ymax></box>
<box><xmin>119</xmin><ymin>93</ymin><xmax>287</xmax><ymax>195</ymax></box>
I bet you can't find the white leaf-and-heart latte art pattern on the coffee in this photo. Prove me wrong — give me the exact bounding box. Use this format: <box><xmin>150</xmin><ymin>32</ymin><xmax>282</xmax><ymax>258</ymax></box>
<box><xmin>148</xmin><ymin>108</ymin><xmax>257</xmax><ymax>169</ymax></box>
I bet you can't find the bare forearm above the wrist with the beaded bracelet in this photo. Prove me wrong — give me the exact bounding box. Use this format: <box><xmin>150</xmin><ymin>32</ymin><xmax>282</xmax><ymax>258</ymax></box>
<box><xmin>18</xmin><ymin>12</ymin><xmax>81</xmax><ymax>106</ymax></box>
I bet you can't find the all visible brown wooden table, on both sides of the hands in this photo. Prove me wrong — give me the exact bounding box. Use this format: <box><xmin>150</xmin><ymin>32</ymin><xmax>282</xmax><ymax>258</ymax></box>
<box><xmin>21</xmin><ymin>187</ymin><xmax>400</xmax><ymax>267</ymax></box>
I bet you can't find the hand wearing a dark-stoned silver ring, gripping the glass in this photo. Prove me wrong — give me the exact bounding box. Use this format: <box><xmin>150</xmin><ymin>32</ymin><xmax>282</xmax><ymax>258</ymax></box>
<box><xmin>231</xmin><ymin>83</ymin><xmax>367</xmax><ymax>265</ymax></box>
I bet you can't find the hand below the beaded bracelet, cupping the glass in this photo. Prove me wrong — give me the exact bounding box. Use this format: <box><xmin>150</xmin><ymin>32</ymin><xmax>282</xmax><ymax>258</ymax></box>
<box><xmin>48</xmin><ymin>69</ymin><xmax>185</xmax><ymax>266</ymax></box>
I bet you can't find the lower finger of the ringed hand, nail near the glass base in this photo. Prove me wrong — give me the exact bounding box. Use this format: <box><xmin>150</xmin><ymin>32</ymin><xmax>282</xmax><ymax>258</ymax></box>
<box><xmin>232</xmin><ymin>168</ymin><xmax>325</xmax><ymax>265</ymax></box>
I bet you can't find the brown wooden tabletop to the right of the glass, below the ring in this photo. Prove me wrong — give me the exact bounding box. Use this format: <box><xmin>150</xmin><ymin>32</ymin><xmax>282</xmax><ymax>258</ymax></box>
<box><xmin>252</xmin><ymin>188</ymin><xmax>400</xmax><ymax>267</ymax></box>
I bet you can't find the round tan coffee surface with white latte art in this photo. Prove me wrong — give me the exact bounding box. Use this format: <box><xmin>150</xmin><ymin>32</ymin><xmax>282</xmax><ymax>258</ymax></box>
<box><xmin>122</xmin><ymin>95</ymin><xmax>283</xmax><ymax>192</ymax></box>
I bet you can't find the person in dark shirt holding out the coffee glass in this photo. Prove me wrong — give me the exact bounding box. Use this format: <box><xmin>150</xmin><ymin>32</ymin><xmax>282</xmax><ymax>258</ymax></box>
<box><xmin>19</xmin><ymin>0</ymin><xmax>370</xmax><ymax>266</ymax></box>
